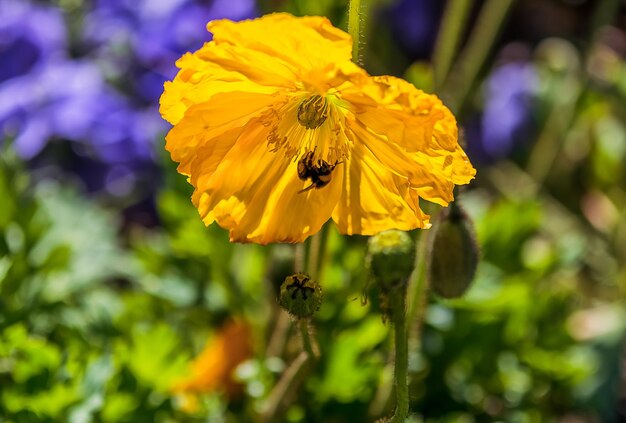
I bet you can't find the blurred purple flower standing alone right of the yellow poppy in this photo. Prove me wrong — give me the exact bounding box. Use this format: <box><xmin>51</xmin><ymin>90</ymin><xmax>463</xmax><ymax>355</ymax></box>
<box><xmin>467</xmin><ymin>62</ymin><xmax>538</xmax><ymax>160</ymax></box>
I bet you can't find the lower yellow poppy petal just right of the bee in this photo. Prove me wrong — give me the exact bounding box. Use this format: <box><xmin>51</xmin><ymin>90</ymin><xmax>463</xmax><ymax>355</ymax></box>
<box><xmin>333</xmin><ymin>143</ymin><xmax>430</xmax><ymax>235</ymax></box>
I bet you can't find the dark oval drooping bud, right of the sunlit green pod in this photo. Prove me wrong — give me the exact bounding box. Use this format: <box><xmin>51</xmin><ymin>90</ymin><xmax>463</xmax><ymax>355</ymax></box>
<box><xmin>428</xmin><ymin>203</ymin><xmax>480</xmax><ymax>298</ymax></box>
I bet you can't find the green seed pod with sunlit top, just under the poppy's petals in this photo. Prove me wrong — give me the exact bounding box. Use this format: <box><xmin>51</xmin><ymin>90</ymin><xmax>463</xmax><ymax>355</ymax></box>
<box><xmin>368</xmin><ymin>229</ymin><xmax>415</xmax><ymax>291</ymax></box>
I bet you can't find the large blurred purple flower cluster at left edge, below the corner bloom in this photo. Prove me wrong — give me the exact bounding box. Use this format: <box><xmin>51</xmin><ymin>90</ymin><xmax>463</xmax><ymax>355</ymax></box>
<box><xmin>0</xmin><ymin>60</ymin><xmax>149</xmax><ymax>161</ymax></box>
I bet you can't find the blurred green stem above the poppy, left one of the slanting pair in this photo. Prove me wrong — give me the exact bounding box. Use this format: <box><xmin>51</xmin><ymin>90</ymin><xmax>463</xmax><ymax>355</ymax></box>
<box><xmin>433</xmin><ymin>0</ymin><xmax>474</xmax><ymax>90</ymax></box>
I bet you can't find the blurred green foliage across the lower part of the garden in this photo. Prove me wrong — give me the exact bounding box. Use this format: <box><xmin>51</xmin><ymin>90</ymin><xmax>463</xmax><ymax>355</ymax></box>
<box><xmin>0</xmin><ymin>141</ymin><xmax>626</xmax><ymax>422</ymax></box>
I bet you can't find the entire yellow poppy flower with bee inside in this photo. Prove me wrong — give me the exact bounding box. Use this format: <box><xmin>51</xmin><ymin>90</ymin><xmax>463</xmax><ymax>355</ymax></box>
<box><xmin>160</xmin><ymin>13</ymin><xmax>475</xmax><ymax>244</ymax></box>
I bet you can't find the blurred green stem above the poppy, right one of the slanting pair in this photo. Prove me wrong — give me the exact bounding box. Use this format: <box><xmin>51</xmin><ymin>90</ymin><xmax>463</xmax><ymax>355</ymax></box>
<box><xmin>446</xmin><ymin>0</ymin><xmax>515</xmax><ymax>113</ymax></box>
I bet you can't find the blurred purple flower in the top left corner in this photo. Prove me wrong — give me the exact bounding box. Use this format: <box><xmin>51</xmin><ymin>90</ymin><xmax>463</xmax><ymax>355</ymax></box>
<box><xmin>0</xmin><ymin>0</ymin><xmax>66</xmax><ymax>85</ymax></box>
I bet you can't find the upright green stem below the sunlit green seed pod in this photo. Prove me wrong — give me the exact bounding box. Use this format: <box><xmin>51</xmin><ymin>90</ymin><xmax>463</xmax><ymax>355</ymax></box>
<box><xmin>389</xmin><ymin>286</ymin><xmax>409</xmax><ymax>423</ymax></box>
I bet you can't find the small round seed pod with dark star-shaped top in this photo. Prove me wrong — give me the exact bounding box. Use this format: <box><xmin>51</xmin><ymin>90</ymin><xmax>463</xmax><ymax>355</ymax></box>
<box><xmin>278</xmin><ymin>273</ymin><xmax>322</xmax><ymax>319</ymax></box>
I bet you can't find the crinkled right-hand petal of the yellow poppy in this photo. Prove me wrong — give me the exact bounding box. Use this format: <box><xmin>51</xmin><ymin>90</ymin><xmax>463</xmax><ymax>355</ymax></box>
<box><xmin>342</xmin><ymin>77</ymin><xmax>476</xmax><ymax>205</ymax></box>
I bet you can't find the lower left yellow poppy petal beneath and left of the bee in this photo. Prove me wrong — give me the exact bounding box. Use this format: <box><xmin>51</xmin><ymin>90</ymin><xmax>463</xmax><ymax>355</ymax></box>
<box><xmin>196</xmin><ymin>119</ymin><xmax>342</xmax><ymax>244</ymax></box>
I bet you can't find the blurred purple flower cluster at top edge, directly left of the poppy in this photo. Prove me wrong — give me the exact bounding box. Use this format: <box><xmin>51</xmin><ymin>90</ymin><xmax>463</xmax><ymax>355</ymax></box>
<box><xmin>85</xmin><ymin>0</ymin><xmax>255</xmax><ymax>102</ymax></box>
